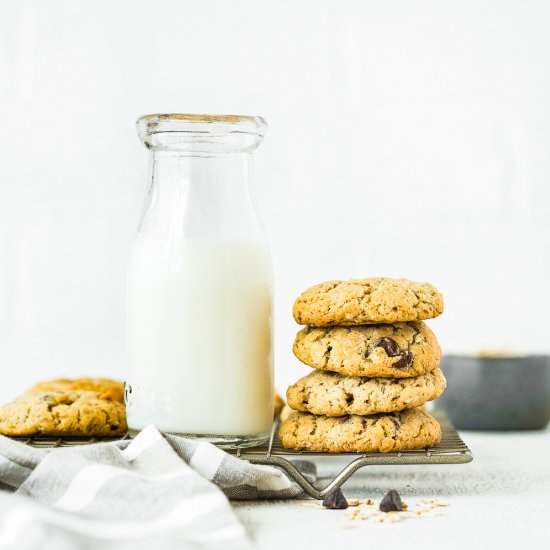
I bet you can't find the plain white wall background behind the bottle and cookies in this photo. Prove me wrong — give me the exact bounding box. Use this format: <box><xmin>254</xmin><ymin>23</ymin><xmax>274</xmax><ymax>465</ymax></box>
<box><xmin>0</xmin><ymin>0</ymin><xmax>550</xmax><ymax>406</ymax></box>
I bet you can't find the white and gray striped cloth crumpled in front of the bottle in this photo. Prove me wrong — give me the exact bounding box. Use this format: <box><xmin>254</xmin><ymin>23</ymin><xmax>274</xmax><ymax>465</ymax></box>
<box><xmin>0</xmin><ymin>426</ymin><xmax>301</xmax><ymax>550</ymax></box>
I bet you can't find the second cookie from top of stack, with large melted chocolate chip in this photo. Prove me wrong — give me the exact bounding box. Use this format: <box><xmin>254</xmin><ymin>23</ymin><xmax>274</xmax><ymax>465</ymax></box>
<box><xmin>292</xmin><ymin>321</ymin><xmax>441</xmax><ymax>378</ymax></box>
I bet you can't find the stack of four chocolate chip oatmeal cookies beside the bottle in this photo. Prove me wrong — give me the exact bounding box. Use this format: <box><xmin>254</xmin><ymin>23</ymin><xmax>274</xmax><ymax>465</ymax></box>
<box><xmin>279</xmin><ymin>278</ymin><xmax>445</xmax><ymax>452</ymax></box>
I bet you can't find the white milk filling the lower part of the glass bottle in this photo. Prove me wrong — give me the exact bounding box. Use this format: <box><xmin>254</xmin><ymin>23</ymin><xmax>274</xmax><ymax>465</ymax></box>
<box><xmin>127</xmin><ymin>234</ymin><xmax>273</xmax><ymax>435</ymax></box>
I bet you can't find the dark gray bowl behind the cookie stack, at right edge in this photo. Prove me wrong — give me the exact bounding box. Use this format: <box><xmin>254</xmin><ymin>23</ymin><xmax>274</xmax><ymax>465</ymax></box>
<box><xmin>437</xmin><ymin>355</ymin><xmax>550</xmax><ymax>430</ymax></box>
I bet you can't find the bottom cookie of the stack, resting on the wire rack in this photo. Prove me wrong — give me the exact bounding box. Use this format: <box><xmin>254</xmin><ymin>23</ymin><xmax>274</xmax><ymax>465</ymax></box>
<box><xmin>279</xmin><ymin>409</ymin><xmax>441</xmax><ymax>453</ymax></box>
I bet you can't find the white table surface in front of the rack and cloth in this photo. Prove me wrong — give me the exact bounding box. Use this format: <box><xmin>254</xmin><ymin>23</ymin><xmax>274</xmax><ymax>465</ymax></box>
<box><xmin>234</xmin><ymin>429</ymin><xmax>550</xmax><ymax>550</ymax></box>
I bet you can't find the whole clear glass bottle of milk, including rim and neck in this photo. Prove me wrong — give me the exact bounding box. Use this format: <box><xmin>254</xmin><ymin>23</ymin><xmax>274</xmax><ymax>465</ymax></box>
<box><xmin>125</xmin><ymin>114</ymin><xmax>273</xmax><ymax>445</ymax></box>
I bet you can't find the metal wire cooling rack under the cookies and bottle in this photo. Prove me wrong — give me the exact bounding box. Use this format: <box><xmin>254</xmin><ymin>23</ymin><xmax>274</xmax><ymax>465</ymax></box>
<box><xmin>12</xmin><ymin>411</ymin><xmax>473</xmax><ymax>499</ymax></box>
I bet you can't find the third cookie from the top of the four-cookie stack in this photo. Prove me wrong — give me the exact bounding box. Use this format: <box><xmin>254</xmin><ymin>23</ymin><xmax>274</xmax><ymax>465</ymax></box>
<box><xmin>286</xmin><ymin>369</ymin><xmax>446</xmax><ymax>416</ymax></box>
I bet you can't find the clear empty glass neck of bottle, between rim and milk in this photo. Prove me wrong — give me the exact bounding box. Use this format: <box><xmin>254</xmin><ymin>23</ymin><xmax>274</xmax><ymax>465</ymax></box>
<box><xmin>139</xmin><ymin>151</ymin><xmax>263</xmax><ymax>238</ymax></box>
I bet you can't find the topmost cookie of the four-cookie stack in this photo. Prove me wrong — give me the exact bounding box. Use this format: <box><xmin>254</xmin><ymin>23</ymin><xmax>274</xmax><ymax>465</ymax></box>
<box><xmin>293</xmin><ymin>277</ymin><xmax>443</xmax><ymax>327</ymax></box>
